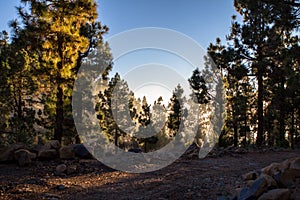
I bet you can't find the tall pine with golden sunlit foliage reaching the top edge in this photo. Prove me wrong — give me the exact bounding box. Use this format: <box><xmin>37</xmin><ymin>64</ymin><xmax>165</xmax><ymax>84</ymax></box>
<box><xmin>19</xmin><ymin>0</ymin><xmax>105</xmax><ymax>141</ymax></box>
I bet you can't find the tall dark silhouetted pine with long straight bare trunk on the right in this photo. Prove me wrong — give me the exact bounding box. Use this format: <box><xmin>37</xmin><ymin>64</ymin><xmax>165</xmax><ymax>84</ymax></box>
<box><xmin>228</xmin><ymin>0</ymin><xmax>299</xmax><ymax>146</ymax></box>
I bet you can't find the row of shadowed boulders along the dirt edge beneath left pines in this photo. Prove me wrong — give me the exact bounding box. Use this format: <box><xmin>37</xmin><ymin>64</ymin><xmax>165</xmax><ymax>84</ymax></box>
<box><xmin>0</xmin><ymin>140</ymin><xmax>93</xmax><ymax>166</ymax></box>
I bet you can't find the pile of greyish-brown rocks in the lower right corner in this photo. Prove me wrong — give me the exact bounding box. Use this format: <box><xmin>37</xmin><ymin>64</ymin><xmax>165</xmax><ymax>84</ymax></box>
<box><xmin>231</xmin><ymin>157</ymin><xmax>300</xmax><ymax>200</ymax></box>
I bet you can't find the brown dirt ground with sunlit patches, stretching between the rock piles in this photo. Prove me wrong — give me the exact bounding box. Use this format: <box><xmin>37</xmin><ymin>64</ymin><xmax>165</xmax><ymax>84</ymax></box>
<box><xmin>0</xmin><ymin>150</ymin><xmax>300</xmax><ymax>200</ymax></box>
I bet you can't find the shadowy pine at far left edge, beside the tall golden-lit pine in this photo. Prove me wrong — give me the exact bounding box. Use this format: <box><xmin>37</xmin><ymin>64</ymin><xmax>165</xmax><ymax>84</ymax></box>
<box><xmin>1</xmin><ymin>21</ymin><xmax>39</xmax><ymax>144</ymax></box>
